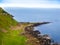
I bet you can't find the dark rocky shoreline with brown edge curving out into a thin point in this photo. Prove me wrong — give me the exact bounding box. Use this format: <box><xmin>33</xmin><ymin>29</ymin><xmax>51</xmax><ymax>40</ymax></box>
<box><xmin>24</xmin><ymin>22</ymin><xmax>60</xmax><ymax>45</ymax></box>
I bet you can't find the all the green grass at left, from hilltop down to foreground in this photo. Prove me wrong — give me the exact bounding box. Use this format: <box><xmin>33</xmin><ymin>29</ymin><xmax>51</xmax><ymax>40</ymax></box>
<box><xmin>0</xmin><ymin>8</ymin><xmax>26</xmax><ymax>45</ymax></box>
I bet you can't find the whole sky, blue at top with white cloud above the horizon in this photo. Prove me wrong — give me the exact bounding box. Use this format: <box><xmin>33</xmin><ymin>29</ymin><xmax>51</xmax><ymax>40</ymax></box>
<box><xmin>0</xmin><ymin>0</ymin><xmax>60</xmax><ymax>8</ymax></box>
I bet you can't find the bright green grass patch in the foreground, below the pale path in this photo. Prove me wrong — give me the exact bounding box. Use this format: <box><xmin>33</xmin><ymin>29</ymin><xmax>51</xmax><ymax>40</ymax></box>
<box><xmin>3</xmin><ymin>30</ymin><xmax>26</xmax><ymax>45</ymax></box>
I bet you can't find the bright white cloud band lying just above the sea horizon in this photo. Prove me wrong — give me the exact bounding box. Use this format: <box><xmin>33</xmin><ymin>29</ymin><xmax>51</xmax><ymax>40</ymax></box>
<box><xmin>0</xmin><ymin>3</ymin><xmax>60</xmax><ymax>8</ymax></box>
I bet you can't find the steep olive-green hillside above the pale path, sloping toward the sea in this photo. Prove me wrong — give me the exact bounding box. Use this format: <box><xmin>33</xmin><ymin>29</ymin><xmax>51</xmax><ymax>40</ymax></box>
<box><xmin>0</xmin><ymin>8</ymin><xmax>17</xmax><ymax>29</ymax></box>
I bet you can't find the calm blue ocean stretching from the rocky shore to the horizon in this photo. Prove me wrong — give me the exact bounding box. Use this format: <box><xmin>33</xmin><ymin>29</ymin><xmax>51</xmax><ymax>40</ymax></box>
<box><xmin>4</xmin><ymin>7</ymin><xmax>60</xmax><ymax>42</ymax></box>
